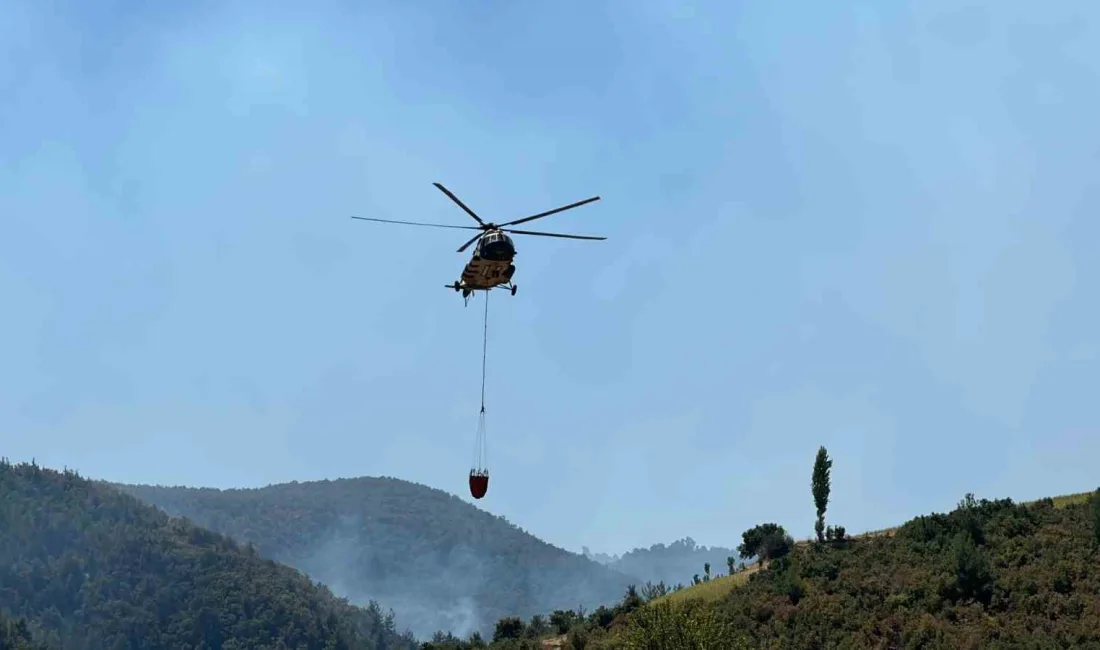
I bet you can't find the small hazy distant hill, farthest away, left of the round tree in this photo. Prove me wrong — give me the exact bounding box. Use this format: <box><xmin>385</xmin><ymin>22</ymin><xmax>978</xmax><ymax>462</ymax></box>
<box><xmin>584</xmin><ymin>537</ymin><xmax>741</xmax><ymax>587</ymax></box>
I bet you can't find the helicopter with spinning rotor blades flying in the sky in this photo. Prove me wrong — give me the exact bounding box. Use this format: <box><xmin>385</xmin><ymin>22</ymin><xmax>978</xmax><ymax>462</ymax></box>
<box><xmin>352</xmin><ymin>183</ymin><xmax>607</xmax><ymax>305</ymax></box>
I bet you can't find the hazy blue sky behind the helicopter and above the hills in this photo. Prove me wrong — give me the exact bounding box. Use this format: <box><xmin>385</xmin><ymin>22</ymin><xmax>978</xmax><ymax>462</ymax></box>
<box><xmin>0</xmin><ymin>0</ymin><xmax>1100</xmax><ymax>552</ymax></box>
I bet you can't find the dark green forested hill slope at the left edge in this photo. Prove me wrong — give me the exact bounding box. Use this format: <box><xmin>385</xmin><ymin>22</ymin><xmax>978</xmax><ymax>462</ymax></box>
<box><xmin>0</xmin><ymin>461</ymin><xmax>415</xmax><ymax>650</ymax></box>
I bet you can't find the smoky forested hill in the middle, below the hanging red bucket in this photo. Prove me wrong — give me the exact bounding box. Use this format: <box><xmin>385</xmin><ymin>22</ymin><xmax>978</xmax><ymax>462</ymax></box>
<box><xmin>120</xmin><ymin>477</ymin><xmax>635</xmax><ymax>637</ymax></box>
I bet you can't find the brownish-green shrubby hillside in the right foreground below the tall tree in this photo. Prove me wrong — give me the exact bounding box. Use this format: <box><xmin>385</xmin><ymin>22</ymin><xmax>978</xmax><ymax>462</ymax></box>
<box><xmin>415</xmin><ymin>491</ymin><xmax>1100</xmax><ymax>650</ymax></box>
